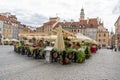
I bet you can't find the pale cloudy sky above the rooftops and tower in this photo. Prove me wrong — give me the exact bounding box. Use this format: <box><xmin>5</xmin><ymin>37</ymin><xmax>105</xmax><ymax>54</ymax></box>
<box><xmin>0</xmin><ymin>0</ymin><xmax>120</xmax><ymax>31</ymax></box>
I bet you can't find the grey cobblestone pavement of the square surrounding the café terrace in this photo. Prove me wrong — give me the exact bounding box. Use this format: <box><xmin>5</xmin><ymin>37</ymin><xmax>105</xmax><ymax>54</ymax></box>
<box><xmin>0</xmin><ymin>46</ymin><xmax>120</xmax><ymax>80</ymax></box>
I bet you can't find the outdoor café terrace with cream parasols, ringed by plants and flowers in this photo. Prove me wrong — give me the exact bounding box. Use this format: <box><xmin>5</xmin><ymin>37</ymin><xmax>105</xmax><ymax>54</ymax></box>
<box><xmin>15</xmin><ymin>26</ymin><xmax>97</xmax><ymax>64</ymax></box>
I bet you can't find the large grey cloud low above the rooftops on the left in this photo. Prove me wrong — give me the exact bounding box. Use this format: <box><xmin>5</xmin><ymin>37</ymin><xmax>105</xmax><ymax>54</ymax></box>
<box><xmin>0</xmin><ymin>9</ymin><xmax>48</xmax><ymax>26</ymax></box>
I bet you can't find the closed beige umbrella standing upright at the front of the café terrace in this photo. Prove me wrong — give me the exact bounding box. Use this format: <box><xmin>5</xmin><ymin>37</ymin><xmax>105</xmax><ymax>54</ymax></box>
<box><xmin>54</xmin><ymin>26</ymin><xmax>65</xmax><ymax>51</ymax></box>
